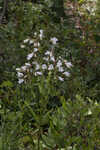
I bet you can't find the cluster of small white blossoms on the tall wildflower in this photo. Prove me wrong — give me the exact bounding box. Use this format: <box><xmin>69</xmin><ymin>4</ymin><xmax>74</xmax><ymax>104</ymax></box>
<box><xmin>16</xmin><ymin>30</ymin><xmax>72</xmax><ymax>84</ymax></box>
